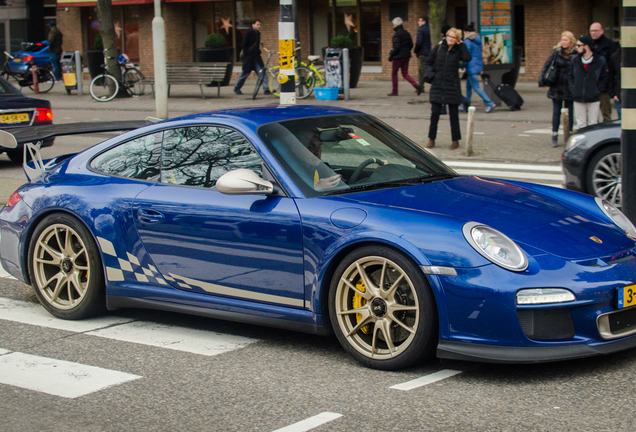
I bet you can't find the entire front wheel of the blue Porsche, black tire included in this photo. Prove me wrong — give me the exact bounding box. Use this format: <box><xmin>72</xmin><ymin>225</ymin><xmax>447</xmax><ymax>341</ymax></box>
<box><xmin>329</xmin><ymin>246</ymin><xmax>438</xmax><ymax>370</ymax></box>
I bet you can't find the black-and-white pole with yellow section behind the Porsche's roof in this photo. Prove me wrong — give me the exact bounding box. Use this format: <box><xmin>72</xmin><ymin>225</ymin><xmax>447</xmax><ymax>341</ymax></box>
<box><xmin>280</xmin><ymin>0</ymin><xmax>296</xmax><ymax>105</ymax></box>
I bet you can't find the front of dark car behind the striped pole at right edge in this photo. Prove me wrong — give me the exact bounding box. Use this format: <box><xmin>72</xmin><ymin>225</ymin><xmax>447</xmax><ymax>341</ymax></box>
<box><xmin>561</xmin><ymin>120</ymin><xmax>621</xmax><ymax>207</ymax></box>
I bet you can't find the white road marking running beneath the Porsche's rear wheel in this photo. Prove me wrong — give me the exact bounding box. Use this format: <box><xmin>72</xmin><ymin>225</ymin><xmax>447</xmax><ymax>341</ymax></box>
<box><xmin>0</xmin><ymin>297</ymin><xmax>257</xmax><ymax>356</ymax></box>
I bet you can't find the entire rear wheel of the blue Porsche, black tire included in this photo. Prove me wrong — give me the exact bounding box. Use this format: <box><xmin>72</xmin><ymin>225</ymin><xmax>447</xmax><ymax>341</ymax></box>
<box><xmin>28</xmin><ymin>213</ymin><xmax>106</xmax><ymax>320</ymax></box>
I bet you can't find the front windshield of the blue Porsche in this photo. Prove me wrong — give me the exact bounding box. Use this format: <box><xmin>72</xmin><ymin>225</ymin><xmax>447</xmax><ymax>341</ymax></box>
<box><xmin>258</xmin><ymin>114</ymin><xmax>456</xmax><ymax>197</ymax></box>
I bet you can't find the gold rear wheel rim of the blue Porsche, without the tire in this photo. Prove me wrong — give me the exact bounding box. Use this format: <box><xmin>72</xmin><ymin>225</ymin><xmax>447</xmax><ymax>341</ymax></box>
<box><xmin>33</xmin><ymin>224</ymin><xmax>90</xmax><ymax>310</ymax></box>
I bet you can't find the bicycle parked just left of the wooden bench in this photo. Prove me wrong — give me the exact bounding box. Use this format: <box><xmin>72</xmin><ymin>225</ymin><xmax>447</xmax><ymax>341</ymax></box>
<box><xmin>90</xmin><ymin>54</ymin><xmax>145</xmax><ymax>102</ymax></box>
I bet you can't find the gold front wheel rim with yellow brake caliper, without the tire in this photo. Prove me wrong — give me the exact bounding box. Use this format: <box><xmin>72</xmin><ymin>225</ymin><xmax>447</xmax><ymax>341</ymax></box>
<box><xmin>335</xmin><ymin>256</ymin><xmax>420</xmax><ymax>360</ymax></box>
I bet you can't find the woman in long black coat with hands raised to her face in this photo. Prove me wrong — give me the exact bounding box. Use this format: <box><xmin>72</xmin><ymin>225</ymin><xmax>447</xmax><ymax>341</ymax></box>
<box><xmin>426</xmin><ymin>28</ymin><xmax>472</xmax><ymax>150</ymax></box>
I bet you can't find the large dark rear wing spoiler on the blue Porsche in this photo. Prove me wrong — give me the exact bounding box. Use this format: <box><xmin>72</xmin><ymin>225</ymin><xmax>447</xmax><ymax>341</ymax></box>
<box><xmin>0</xmin><ymin>117</ymin><xmax>153</xmax><ymax>181</ymax></box>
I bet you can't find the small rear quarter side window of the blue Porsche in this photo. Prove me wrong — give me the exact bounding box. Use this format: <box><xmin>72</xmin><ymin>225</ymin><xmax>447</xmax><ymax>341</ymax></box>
<box><xmin>91</xmin><ymin>132</ymin><xmax>163</xmax><ymax>181</ymax></box>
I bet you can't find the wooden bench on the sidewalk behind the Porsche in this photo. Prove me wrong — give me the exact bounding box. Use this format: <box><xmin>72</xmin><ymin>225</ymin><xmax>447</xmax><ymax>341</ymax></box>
<box><xmin>148</xmin><ymin>63</ymin><xmax>232</xmax><ymax>99</ymax></box>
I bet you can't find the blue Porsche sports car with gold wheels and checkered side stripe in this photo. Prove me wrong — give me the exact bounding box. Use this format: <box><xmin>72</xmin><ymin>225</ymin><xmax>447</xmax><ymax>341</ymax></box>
<box><xmin>0</xmin><ymin>106</ymin><xmax>636</xmax><ymax>369</ymax></box>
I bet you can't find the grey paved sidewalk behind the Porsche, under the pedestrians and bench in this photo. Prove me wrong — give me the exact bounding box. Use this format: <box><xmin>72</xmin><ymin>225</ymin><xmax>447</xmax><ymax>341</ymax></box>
<box><xmin>31</xmin><ymin>80</ymin><xmax>616</xmax><ymax>165</ymax></box>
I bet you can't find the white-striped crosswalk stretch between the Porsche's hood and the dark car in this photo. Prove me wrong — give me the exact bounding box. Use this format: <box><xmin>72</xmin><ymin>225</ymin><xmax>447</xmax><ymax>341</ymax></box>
<box><xmin>444</xmin><ymin>161</ymin><xmax>563</xmax><ymax>188</ymax></box>
